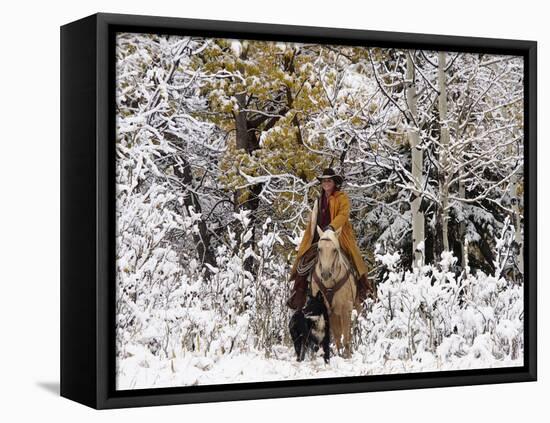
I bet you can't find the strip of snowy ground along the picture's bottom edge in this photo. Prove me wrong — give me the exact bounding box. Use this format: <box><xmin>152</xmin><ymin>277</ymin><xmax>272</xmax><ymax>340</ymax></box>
<box><xmin>117</xmin><ymin>346</ymin><xmax>523</xmax><ymax>390</ymax></box>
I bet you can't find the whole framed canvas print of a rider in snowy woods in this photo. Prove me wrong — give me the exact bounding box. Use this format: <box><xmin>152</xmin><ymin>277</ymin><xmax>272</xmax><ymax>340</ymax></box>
<box><xmin>61</xmin><ymin>13</ymin><xmax>536</xmax><ymax>408</ymax></box>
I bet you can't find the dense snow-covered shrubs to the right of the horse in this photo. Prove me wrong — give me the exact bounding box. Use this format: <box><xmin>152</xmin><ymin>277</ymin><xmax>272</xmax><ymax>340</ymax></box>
<box><xmin>354</xmin><ymin>242</ymin><xmax>523</xmax><ymax>368</ymax></box>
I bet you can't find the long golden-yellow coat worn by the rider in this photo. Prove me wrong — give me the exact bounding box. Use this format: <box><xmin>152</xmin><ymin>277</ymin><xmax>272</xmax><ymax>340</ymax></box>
<box><xmin>290</xmin><ymin>191</ymin><xmax>367</xmax><ymax>279</ymax></box>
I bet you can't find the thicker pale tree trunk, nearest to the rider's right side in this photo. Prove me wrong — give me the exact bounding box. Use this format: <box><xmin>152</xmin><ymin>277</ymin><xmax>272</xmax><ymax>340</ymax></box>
<box><xmin>406</xmin><ymin>52</ymin><xmax>425</xmax><ymax>267</ymax></box>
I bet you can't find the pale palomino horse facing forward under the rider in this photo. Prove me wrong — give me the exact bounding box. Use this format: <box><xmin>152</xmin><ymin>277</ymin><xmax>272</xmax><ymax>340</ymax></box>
<box><xmin>311</xmin><ymin>226</ymin><xmax>357</xmax><ymax>358</ymax></box>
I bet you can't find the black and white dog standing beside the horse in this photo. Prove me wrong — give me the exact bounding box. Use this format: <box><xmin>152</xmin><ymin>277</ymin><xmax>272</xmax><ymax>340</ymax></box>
<box><xmin>289</xmin><ymin>292</ymin><xmax>330</xmax><ymax>363</ymax></box>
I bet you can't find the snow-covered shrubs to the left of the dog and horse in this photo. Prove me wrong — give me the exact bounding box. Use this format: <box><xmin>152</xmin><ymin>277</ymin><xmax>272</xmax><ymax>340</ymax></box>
<box><xmin>117</xmin><ymin>199</ymin><xmax>294</xmax><ymax>368</ymax></box>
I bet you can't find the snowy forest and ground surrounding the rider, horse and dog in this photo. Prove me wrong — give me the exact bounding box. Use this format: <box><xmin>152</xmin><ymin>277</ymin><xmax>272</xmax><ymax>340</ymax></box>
<box><xmin>115</xmin><ymin>33</ymin><xmax>524</xmax><ymax>389</ymax></box>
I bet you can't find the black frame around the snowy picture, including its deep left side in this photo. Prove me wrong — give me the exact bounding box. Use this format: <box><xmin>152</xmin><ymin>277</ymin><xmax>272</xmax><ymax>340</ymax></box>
<box><xmin>60</xmin><ymin>13</ymin><xmax>537</xmax><ymax>409</ymax></box>
